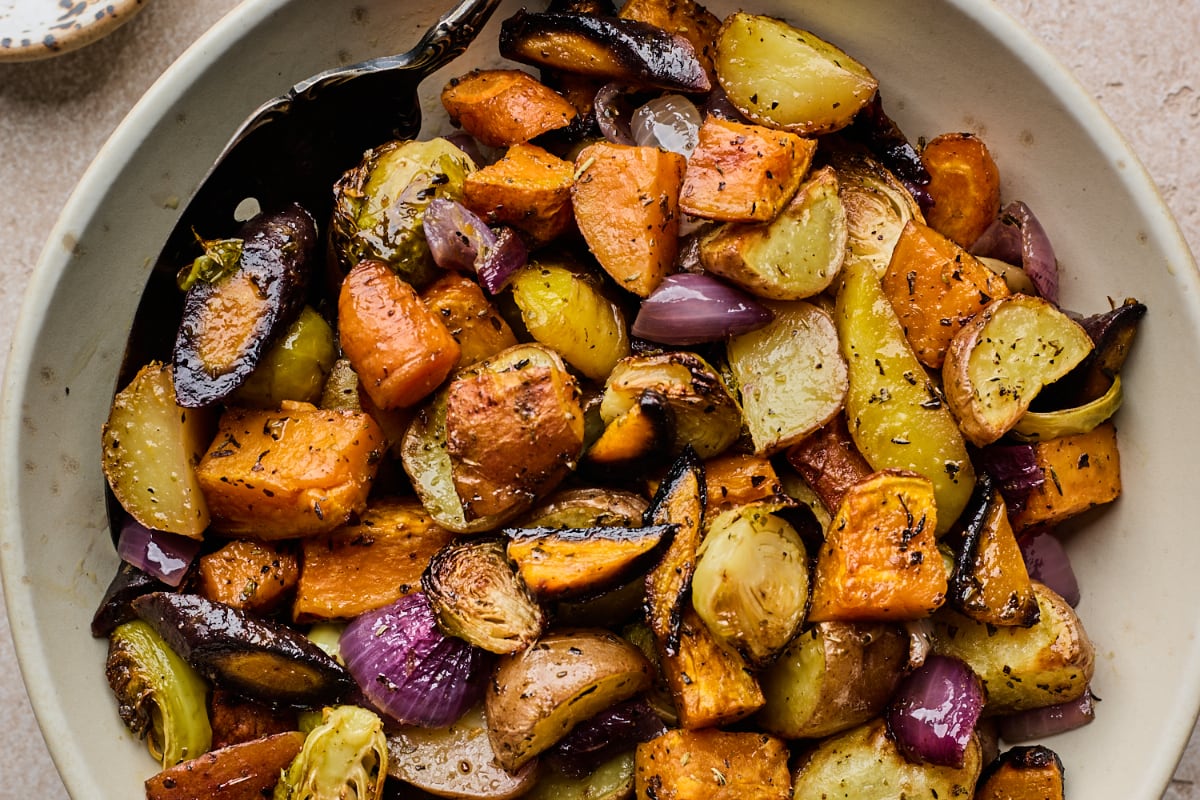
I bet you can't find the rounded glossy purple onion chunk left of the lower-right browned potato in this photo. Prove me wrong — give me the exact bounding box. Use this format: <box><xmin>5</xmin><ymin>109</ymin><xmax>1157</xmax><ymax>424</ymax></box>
<box><xmin>887</xmin><ymin>655</ymin><xmax>984</xmax><ymax>768</ymax></box>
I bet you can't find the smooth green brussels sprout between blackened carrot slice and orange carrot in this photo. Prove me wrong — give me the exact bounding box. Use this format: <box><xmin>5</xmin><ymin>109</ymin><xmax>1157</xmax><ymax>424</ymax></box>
<box><xmin>233</xmin><ymin>306</ymin><xmax>337</xmax><ymax>409</ymax></box>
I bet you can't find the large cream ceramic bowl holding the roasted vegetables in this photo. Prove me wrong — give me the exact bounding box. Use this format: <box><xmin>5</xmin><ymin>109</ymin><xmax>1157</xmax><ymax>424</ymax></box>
<box><xmin>0</xmin><ymin>0</ymin><xmax>1200</xmax><ymax>800</ymax></box>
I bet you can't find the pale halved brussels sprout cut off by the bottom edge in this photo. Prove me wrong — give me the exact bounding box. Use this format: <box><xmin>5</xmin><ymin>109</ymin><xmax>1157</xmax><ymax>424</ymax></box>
<box><xmin>275</xmin><ymin>705</ymin><xmax>388</xmax><ymax>800</ymax></box>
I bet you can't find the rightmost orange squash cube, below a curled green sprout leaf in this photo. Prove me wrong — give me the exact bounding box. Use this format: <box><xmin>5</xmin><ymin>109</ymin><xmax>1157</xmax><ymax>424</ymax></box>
<box><xmin>1013</xmin><ymin>422</ymin><xmax>1121</xmax><ymax>531</ymax></box>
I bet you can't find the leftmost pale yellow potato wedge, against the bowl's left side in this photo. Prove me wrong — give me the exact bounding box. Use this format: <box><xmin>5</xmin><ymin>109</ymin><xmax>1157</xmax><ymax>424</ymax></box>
<box><xmin>101</xmin><ymin>361</ymin><xmax>212</xmax><ymax>539</ymax></box>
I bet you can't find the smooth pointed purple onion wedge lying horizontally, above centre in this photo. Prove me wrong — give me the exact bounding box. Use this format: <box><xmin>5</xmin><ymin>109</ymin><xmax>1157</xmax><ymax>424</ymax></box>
<box><xmin>630</xmin><ymin>272</ymin><xmax>774</xmax><ymax>345</ymax></box>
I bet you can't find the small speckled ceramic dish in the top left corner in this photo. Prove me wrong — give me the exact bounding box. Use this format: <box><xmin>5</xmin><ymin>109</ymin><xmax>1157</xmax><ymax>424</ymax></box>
<box><xmin>0</xmin><ymin>0</ymin><xmax>146</xmax><ymax>61</ymax></box>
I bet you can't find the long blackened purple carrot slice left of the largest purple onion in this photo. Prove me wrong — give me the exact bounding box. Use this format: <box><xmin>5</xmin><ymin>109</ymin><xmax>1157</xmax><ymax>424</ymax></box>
<box><xmin>133</xmin><ymin>591</ymin><xmax>355</xmax><ymax>708</ymax></box>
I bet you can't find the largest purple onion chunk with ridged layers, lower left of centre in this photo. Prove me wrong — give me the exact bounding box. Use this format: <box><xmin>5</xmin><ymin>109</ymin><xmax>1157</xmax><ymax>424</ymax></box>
<box><xmin>338</xmin><ymin>593</ymin><xmax>486</xmax><ymax>728</ymax></box>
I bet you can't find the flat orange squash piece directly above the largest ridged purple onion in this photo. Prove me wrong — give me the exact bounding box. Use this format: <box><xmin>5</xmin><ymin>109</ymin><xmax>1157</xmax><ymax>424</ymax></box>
<box><xmin>292</xmin><ymin>499</ymin><xmax>455</xmax><ymax>622</ymax></box>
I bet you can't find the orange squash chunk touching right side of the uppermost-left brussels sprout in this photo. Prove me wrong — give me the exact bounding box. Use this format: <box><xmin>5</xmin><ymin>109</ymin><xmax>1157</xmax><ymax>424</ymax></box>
<box><xmin>462</xmin><ymin>144</ymin><xmax>575</xmax><ymax>245</ymax></box>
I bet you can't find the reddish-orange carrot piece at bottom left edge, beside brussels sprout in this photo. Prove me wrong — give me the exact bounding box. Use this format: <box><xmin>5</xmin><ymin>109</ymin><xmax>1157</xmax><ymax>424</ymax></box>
<box><xmin>145</xmin><ymin>730</ymin><xmax>304</xmax><ymax>800</ymax></box>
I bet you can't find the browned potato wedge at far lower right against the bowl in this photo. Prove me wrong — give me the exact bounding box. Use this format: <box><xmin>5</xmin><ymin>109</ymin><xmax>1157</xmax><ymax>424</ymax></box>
<box><xmin>934</xmin><ymin>582</ymin><xmax>1096</xmax><ymax>714</ymax></box>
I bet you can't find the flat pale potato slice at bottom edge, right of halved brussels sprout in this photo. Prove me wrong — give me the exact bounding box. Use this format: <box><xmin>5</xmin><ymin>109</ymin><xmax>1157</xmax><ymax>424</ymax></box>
<box><xmin>388</xmin><ymin>704</ymin><xmax>539</xmax><ymax>800</ymax></box>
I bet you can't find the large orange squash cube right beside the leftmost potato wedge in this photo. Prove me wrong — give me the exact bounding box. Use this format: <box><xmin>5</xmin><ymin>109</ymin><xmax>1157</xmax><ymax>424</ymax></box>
<box><xmin>196</xmin><ymin>402</ymin><xmax>383</xmax><ymax>540</ymax></box>
